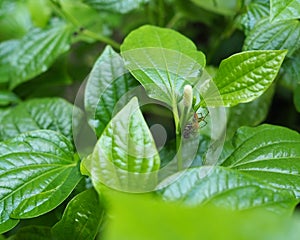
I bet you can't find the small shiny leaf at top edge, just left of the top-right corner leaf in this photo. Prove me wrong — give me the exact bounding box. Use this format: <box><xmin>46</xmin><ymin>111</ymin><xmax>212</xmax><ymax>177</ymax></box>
<box><xmin>237</xmin><ymin>0</ymin><xmax>270</xmax><ymax>35</ymax></box>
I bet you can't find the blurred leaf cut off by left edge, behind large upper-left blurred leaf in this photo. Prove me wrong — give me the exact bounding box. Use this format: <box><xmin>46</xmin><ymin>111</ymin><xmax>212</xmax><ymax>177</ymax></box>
<box><xmin>0</xmin><ymin>40</ymin><xmax>20</xmax><ymax>83</ymax></box>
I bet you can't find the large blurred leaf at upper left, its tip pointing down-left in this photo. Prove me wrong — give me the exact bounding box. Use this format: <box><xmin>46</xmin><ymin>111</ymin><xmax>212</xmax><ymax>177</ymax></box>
<box><xmin>9</xmin><ymin>22</ymin><xmax>72</xmax><ymax>89</ymax></box>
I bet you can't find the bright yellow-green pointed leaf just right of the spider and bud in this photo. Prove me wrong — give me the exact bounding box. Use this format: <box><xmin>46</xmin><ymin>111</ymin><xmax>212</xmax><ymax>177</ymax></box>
<box><xmin>205</xmin><ymin>50</ymin><xmax>286</xmax><ymax>106</ymax></box>
